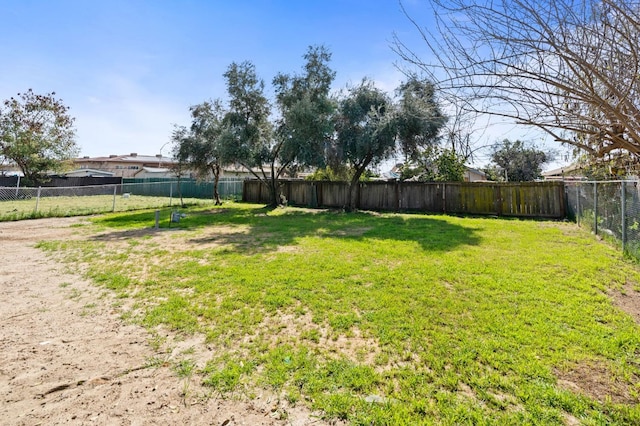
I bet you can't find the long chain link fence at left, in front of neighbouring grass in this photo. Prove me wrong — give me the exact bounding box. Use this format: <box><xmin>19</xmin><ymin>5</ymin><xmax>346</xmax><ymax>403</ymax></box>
<box><xmin>0</xmin><ymin>181</ymin><xmax>242</xmax><ymax>221</ymax></box>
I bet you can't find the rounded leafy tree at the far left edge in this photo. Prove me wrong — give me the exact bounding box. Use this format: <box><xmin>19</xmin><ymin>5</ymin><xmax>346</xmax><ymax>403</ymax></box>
<box><xmin>0</xmin><ymin>89</ymin><xmax>78</xmax><ymax>183</ymax></box>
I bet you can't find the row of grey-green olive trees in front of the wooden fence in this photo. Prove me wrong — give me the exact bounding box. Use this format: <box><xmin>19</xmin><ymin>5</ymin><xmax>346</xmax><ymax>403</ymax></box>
<box><xmin>172</xmin><ymin>46</ymin><xmax>446</xmax><ymax>208</ymax></box>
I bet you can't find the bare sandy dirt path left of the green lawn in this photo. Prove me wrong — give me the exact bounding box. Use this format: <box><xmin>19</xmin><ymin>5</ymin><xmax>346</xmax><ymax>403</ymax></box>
<box><xmin>0</xmin><ymin>218</ymin><xmax>324</xmax><ymax>426</ymax></box>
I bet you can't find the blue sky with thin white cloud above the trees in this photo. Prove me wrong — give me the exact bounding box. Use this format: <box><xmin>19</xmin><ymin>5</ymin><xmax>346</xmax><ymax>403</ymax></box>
<box><xmin>0</xmin><ymin>0</ymin><xmax>564</xmax><ymax>170</ymax></box>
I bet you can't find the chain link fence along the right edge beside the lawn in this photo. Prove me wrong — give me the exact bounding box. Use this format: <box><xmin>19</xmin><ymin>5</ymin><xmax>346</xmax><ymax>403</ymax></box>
<box><xmin>565</xmin><ymin>180</ymin><xmax>640</xmax><ymax>259</ymax></box>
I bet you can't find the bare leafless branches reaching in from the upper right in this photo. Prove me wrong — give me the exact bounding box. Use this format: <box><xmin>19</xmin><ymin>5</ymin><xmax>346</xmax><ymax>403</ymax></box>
<box><xmin>394</xmin><ymin>0</ymin><xmax>640</xmax><ymax>168</ymax></box>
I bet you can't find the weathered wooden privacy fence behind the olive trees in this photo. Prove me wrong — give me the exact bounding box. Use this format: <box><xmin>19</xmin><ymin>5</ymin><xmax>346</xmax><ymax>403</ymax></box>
<box><xmin>242</xmin><ymin>180</ymin><xmax>566</xmax><ymax>219</ymax></box>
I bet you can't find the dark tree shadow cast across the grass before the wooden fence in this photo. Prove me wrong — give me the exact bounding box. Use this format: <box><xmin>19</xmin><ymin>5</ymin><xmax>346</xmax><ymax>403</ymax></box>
<box><xmin>94</xmin><ymin>206</ymin><xmax>480</xmax><ymax>253</ymax></box>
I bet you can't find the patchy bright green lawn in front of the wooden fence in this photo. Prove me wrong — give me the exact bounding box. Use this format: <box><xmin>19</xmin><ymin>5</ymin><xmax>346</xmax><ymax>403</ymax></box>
<box><xmin>42</xmin><ymin>203</ymin><xmax>640</xmax><ymax>425</ymax></box>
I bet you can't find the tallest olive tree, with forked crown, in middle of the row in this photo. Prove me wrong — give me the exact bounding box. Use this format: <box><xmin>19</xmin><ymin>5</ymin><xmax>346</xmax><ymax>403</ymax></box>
<box><xmin>222</xmin><ymin>47</ymin><xmax>335</xmax><ymax>206</ymax></box>
